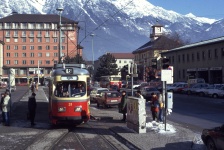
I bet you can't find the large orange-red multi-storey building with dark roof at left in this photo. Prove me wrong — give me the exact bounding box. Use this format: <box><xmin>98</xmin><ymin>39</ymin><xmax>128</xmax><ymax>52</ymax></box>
<box><xmin>0</xmin><ymin>14</ymin><xmax>82</xmax><ymax>83</ymax></box>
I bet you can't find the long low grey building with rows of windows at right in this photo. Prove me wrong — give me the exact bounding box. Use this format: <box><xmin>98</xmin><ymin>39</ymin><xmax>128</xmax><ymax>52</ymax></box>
<box><xmin>161</xmin><ymin>37</ymin><xmax>224</xmax><ymax>83</ymax></box>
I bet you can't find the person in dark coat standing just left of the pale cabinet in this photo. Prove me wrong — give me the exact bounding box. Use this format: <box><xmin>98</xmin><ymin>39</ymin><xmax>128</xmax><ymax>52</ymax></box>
<box><xmin>118</xmin><ymin>91</ymin><xmax>127</xmax><ymax>121</ymax></box>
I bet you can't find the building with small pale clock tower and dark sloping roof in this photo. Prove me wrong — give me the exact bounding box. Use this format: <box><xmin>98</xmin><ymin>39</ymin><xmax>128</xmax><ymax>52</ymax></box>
<box><xmin>132</xmin><ymin>24</ymin><xmax>180</xmax><ymax>81</ymax></box>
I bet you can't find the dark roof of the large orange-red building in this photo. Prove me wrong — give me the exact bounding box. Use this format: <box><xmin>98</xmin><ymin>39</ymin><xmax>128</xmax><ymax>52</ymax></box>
<box><xmin>0</xmin><ymin>14</ymin><xmax>77</xmax><ymax>24</ymax></box>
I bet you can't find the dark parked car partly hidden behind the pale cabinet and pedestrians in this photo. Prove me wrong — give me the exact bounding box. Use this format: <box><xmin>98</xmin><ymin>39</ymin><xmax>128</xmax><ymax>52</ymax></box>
<box><xmin>140</xmin><ymin>86</ymin><xmax>160</xmax><ymax>101</ymax></box>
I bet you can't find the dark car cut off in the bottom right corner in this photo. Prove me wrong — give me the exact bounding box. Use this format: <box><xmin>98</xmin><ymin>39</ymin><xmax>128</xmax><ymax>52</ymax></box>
<box><xmin>201</xmin><ymin>124</ymin><xmax>224</xmax><ymax>150</ymax></box>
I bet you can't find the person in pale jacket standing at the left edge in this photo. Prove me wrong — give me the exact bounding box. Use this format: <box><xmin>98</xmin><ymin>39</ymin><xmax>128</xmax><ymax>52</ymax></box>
<box><xmin>2</xmin><ymin>91</ymin><xmax>10</xmax><ymax>126</ymax></box>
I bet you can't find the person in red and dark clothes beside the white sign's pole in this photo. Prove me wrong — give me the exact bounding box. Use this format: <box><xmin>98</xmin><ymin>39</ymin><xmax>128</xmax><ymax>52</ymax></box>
<box><xmin>150</xmin><ymin>93</ymin><xmax>159</xmax><ymax>121</ymax></box>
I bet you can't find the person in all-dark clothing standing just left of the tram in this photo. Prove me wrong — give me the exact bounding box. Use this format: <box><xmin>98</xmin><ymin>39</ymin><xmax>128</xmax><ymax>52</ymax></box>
<box><xmin>28</xmin><ymin>93</ymin><xmax>37</xmax><ymax>126</ymax></box>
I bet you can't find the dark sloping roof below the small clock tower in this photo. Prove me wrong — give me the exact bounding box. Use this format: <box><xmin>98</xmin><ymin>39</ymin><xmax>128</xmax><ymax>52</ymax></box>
<box><xmin>132</xmin><ymin>36</ymin><xmax>181</xmax><ymax>54</ymax></box>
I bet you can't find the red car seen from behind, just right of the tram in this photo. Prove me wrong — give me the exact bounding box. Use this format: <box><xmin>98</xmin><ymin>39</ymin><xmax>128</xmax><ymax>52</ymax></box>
<box><xmin>96</xmin><ymin>91</ymin><xmax>121</xmax><ymax>108</ymax></box>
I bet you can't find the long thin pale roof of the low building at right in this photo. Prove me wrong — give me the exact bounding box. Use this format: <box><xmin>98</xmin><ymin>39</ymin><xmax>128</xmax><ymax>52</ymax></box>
<box><xmin>162</xmin><ymin>36</ymin><xmax>224</xmax><ymax>54</ymax></box>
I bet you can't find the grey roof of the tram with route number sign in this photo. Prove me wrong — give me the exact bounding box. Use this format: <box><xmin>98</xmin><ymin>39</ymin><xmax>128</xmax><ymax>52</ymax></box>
<box><xmin>52</xmin><ymin>64</ymin><xmax>89</xmax><ymax>76</ymax></box>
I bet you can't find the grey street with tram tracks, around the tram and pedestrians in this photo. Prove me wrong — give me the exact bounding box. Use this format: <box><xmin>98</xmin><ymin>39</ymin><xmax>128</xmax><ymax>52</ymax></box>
<box><xmin>0</xmin><ymin>87</ymin><xmax>224</xmax><ymax>149</ymax></box>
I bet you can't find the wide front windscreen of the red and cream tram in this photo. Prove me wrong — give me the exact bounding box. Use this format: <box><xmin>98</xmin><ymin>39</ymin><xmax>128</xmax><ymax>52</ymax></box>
<box><xmin>54</xmin><ymin>81</ymin><xmax>86</xmax><ymax>97</ymax></box>
